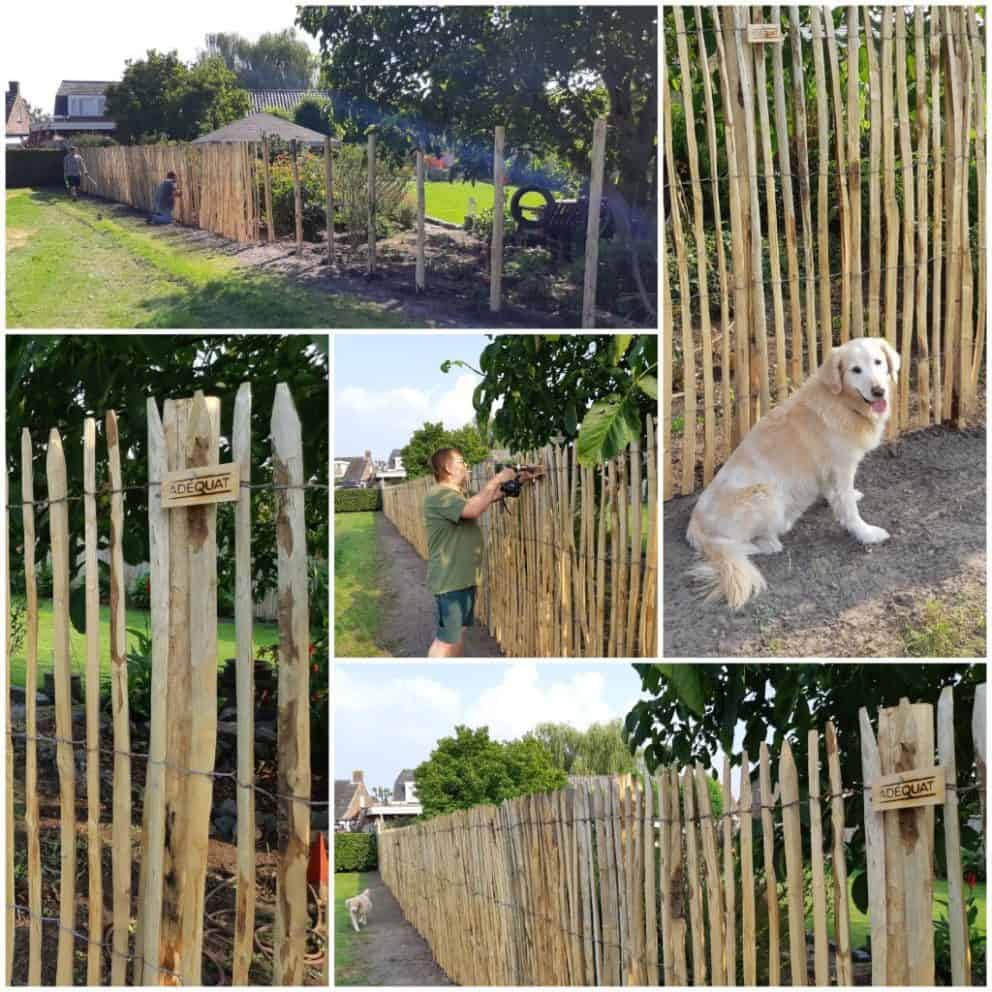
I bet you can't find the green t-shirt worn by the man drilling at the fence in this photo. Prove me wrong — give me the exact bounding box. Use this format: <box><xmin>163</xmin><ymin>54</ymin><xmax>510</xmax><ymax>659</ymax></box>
<box><xmin>424</xmin><ymin>485</ymin><xmax>482</xmax><ymax>596</ymax></box>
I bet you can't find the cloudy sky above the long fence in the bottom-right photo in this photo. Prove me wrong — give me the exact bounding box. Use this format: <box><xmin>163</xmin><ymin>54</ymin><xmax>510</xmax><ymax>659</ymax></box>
<box><xmin>331</xmin><ymin>659</ymin><xmax>641</xmax><ymax>789</ymax></box>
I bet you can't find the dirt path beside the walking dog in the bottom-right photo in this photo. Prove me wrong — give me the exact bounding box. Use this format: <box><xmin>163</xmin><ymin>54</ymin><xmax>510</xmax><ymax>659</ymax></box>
<box><xmin>357</xmin><ymin>872</ymin><xmax>454</xmax><ymax>985</ymax></box>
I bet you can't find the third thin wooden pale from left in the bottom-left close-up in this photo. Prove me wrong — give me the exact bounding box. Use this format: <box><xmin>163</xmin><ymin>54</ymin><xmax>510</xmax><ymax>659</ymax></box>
<box><xmin>83</xmin><ymin>417</ymin><xmax>103</xmax><ymax>985</ymax></box>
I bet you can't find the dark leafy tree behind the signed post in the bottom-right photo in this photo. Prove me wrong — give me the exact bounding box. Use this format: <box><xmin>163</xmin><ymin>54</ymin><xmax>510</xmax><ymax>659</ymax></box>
<box><xmin>626</xmin><ymin>662</ymin><xmax>985</xmax><ymax>911</ymax></box>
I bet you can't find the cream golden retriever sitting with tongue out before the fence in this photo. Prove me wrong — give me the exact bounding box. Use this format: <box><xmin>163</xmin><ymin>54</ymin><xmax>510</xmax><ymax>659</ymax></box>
<box><xmin>686</xmin><ymin>338</ymin><xmax>900</xmax><ymax>609</ymax></box>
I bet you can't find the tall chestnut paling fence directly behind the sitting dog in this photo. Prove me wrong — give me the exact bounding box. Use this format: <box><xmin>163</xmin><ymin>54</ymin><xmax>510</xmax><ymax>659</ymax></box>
<box><xmin>662</xmin><ymin>5</ymin><xmax>986</xmax><ymax>499</ymax></box>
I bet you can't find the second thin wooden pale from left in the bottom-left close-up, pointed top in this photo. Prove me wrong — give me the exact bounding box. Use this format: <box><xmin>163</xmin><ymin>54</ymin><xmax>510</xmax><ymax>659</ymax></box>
<box><xmin>45</xmin><ymin>429</ymin><xmax>76</xmax><ymax>985</ymax></box>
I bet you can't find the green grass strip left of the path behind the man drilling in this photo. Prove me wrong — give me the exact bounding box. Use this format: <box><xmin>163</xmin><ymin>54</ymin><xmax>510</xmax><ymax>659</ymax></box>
<box><xmin>334</xmin><ymin>510</ymin><xmax>388</xmax><ymax>658</ymax></box>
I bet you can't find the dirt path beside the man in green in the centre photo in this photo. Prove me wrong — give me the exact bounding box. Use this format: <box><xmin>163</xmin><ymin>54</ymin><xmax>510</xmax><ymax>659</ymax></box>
<box><xmin>375</xmin><ymin>513</ymin><xmax>502</xmax><ymax>658</ymax></box>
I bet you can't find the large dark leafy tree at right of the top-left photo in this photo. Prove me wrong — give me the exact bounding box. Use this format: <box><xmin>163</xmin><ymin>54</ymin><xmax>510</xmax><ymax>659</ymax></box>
<box><xmin>297</xmin><ymin>6</ymin><xmax>658</xmax><ymax>204</ymax></box>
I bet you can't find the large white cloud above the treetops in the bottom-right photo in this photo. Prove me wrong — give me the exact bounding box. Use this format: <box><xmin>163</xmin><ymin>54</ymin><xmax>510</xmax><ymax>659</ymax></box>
<box><xmin>465</xmin><ymin>662</ymin><xmax>616</xmax><ymax>740</ymax></box>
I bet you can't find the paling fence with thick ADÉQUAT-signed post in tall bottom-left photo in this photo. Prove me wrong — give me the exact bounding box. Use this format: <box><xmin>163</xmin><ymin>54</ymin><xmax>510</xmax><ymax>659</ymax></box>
<box><xmin>5</xmin><ymin>383</ymin><xmax>327</xmax><ymax>985</ymax></box>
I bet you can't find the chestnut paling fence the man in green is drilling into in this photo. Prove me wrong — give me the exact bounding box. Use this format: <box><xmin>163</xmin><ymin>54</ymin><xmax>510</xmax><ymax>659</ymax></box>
<box><xmin>382</xmin><ymin>417</ymin><xmax>658</xmax><ymax>657</ymax></box>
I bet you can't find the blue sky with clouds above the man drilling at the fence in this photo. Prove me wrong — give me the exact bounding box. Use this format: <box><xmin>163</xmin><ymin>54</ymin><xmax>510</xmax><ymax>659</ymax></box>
<box><xmin>334</xmin><ymin>333</ymin><xmax>489</xmax><ymax>458</ymax></box>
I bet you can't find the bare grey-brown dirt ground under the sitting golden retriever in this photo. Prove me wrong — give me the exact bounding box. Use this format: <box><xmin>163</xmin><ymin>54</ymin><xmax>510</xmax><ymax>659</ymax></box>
<box><xmin>664</xmin><ymin>427</ymin><xmax>986</xmax><ymax>658</ymax></box>
